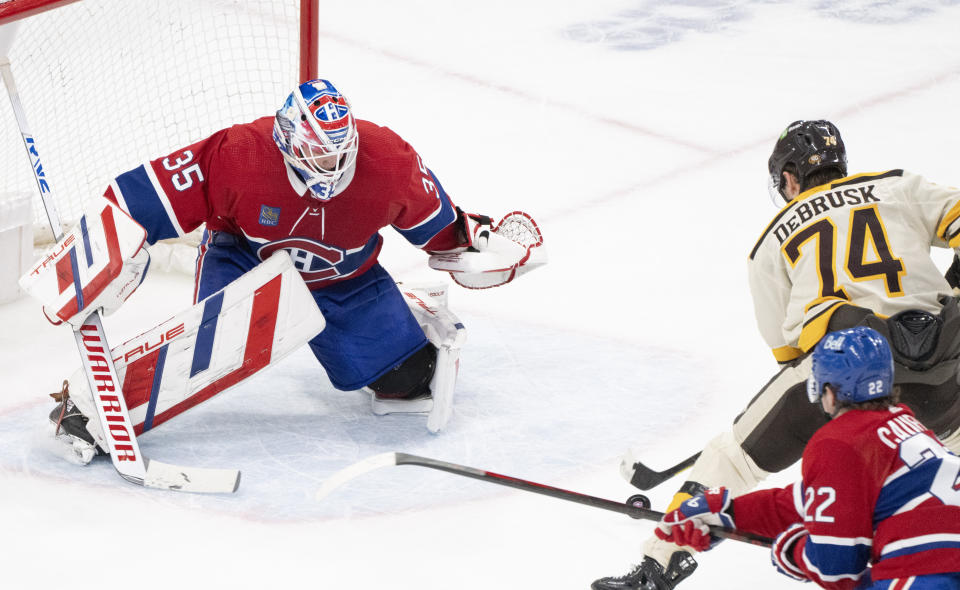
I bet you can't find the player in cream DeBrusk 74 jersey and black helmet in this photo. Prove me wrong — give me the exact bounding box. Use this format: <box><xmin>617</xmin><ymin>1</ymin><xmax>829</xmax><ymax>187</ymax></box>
<box><xmin>593</xmin><ymin>121</ymin><xmax>960</xmax><ymax>590</ymax></box>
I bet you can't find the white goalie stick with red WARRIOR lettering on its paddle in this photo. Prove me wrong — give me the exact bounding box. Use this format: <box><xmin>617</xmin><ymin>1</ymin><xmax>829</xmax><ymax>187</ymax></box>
<box><xmin>0</xmin><ymin>51</ymin><xmax>240</xmax><ymax>493</ymax></box>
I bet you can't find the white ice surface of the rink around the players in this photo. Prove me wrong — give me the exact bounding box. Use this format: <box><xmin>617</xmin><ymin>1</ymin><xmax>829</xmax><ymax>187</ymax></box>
<box><xmin>0</xmin><ymin>0</ymin><xmax>960</xmax><ymax>590</ymax></box>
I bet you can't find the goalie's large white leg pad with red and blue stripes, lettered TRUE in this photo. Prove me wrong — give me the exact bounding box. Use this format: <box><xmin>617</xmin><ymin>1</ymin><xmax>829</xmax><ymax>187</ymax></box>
<box><xmin>64</xmin><ymin>252</ymin><xmax>325</xmax><ymax>449</ymax></box>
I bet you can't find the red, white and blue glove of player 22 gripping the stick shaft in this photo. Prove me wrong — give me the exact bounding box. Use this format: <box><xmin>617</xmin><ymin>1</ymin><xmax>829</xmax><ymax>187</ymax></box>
<box><xmin>654</xmin><ymin>488</ymin><xmax>734</xmax><ymax>551</ymax></box>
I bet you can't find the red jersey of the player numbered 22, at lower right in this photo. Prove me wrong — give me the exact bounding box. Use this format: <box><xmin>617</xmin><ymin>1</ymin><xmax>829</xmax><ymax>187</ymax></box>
<box><xmin>734</xmin><ymin>405</ymin><xmax>960</xmax><ymax>590</ymax></box>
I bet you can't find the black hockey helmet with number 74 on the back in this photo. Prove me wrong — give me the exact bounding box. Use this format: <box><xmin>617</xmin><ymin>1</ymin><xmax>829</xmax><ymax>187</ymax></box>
<box><xmin>767</xmin><ymin>120</ymin><xmax>847</xmax><ymax>200</ymax></box>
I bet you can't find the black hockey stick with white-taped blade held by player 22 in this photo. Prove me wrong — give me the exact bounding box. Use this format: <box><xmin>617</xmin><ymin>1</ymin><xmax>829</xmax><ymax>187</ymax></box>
<box><xmin>316</xmin><ymin>453</ymin><xmax>773</xmax><ymax>547</ymax></box>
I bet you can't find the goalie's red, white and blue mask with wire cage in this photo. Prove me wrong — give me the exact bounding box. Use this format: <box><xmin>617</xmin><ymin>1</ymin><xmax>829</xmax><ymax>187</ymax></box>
<box><xmin>273</xmin><ymin>80</ymin><xmax>359</xmax><ymax>201</ymax></box>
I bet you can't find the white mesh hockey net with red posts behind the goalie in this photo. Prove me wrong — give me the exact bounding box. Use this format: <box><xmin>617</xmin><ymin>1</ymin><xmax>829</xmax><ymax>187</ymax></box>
<box><xmin>0</xmin><ymin>0</ymin><xmax>318</xmax><ymax>272</ymax></box>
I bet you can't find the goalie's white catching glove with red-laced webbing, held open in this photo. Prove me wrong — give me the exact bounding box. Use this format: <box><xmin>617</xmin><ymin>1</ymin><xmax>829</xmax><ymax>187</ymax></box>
<box><xmin>429</xmin><ymin>211</ymin><xmax>547</xmax><ymax>289</ymax></box>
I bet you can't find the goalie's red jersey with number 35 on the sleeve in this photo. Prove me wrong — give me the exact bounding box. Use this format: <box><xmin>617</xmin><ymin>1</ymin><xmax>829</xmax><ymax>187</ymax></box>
<box><xmin>105</xmin><ymin>117</ymin><xmax>460</xmax><ymax>289</ymax></box>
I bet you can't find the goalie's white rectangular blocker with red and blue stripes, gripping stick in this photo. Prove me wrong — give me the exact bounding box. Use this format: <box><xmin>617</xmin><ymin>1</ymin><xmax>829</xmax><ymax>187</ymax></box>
<box><xmin>20</xmin><ymin>199</ymin><xmax>150</xmax><ymax>329</ymax></box>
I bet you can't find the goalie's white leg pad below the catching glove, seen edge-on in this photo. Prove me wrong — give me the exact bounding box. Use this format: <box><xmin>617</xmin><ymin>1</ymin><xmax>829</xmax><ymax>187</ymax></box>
<box><xmin>373</xmin><ymin>283</ymin><xmax>467</xmax><ymax>433</ymax></box>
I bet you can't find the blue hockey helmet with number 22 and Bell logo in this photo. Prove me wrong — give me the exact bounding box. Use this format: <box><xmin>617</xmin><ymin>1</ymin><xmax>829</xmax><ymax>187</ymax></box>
<box><xmin>807</xmin><ymin>326</ymin><xmax>893</xmax><ymax>403</ymax></box>
